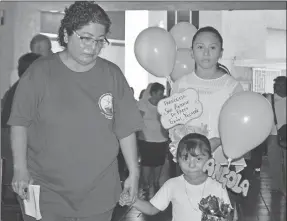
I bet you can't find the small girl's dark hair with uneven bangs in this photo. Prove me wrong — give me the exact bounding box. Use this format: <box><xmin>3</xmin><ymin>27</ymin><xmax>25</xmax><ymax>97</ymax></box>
<box><xmin>176</xmin><ymin>133</ymin><xmax>212</xmax><ymax>161</ymax></box>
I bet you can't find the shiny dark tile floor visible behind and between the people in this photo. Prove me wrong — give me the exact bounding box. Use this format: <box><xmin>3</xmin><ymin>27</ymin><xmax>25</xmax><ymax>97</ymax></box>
<box><xmin>2</xmin><ymin>158</ymin><xmax>286</xmax><ymax>221</ymax></box>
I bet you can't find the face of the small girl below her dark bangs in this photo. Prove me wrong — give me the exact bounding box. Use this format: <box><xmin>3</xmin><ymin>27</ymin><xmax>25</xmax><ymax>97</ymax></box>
<box><xmin>178</xmin><ymin>148</ymin><xmax>209</xmax><ymax>178</ymax></box>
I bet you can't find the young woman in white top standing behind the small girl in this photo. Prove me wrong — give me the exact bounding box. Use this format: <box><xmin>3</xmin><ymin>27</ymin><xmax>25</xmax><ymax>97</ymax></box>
<box><xmin>169</xmin><ymin>27</ymin><xmax>246</xmax><ymax>172</ymax></box>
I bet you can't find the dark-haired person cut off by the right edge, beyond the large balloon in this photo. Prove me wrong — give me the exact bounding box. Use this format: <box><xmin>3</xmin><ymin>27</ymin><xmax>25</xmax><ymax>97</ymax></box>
<box><xmin>266</xmin><ymin>76</ymin><xmax>287</xmax><ymax>196</ymax></box>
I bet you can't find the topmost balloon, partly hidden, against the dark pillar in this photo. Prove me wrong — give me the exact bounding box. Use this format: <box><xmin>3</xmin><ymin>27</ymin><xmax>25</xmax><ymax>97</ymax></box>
<box><xmin>169</xmin><ymin>22</ymin><xmax>197</xmax><ymax>48</ymax></box>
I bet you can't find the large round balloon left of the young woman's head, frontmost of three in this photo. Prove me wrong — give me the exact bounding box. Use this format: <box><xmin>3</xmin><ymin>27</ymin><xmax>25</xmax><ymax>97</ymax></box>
<box><xmin>134</xmin><ymin>27</ymin><xmax>176</xmax><ymax>77</ymax></box>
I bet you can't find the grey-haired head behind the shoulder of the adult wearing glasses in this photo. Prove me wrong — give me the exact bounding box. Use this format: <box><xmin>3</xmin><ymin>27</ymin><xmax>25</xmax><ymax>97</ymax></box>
<box><xmin>30</xmin><ymin>34</ymin><xmax>53</xmax><ymax>56</ymax></box>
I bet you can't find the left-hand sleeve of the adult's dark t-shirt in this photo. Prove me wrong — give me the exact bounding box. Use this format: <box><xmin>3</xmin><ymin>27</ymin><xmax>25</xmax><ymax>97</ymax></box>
<box><xmin>7</xmin><ymin>62</ymin><xmax>45</xmax><ymax>127</ymax></box>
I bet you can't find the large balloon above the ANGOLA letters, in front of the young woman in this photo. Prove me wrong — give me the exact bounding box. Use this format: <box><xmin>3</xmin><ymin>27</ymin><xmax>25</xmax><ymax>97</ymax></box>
<box><xmin>219</xmin><ymin>91</ymin><xmax>273</xmax><ymax>159</ymax></box>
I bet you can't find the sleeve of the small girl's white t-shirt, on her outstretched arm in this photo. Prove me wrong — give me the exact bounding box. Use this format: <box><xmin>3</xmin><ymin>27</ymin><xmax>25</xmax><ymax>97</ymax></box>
<box><xmin>150</xmin><ymin>180</ymin><xmax>173</xmax><ymax>211</ymax></box>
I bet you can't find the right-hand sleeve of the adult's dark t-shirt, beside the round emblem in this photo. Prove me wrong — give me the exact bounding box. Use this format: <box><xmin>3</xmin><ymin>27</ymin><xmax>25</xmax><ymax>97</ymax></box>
<box><xmin>111</xmin><ymin>65</ymin><xmax>143</xmax><ymax>139</ymax></box>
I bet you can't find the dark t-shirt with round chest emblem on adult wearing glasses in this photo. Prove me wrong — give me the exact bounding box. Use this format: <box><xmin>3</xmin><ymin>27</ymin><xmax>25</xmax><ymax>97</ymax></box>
<box><xmin>8</xmin><ymin>54</ymin><xmax>143</xmax><ymax>217</ymax></box>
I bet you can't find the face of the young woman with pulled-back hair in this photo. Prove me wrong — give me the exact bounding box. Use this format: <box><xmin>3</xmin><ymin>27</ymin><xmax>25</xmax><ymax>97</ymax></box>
<box><xmin>192</xmin><ymin>32</ymin><xmax>223</xmax><ymax>69</ymax></box>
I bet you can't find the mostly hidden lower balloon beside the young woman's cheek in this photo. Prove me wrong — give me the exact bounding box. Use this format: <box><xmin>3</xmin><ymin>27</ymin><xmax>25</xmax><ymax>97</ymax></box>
<box><xmin>170</xmin><ymin>48</ymin><xmax>195</xmax><ymax>81</ymax></box>
